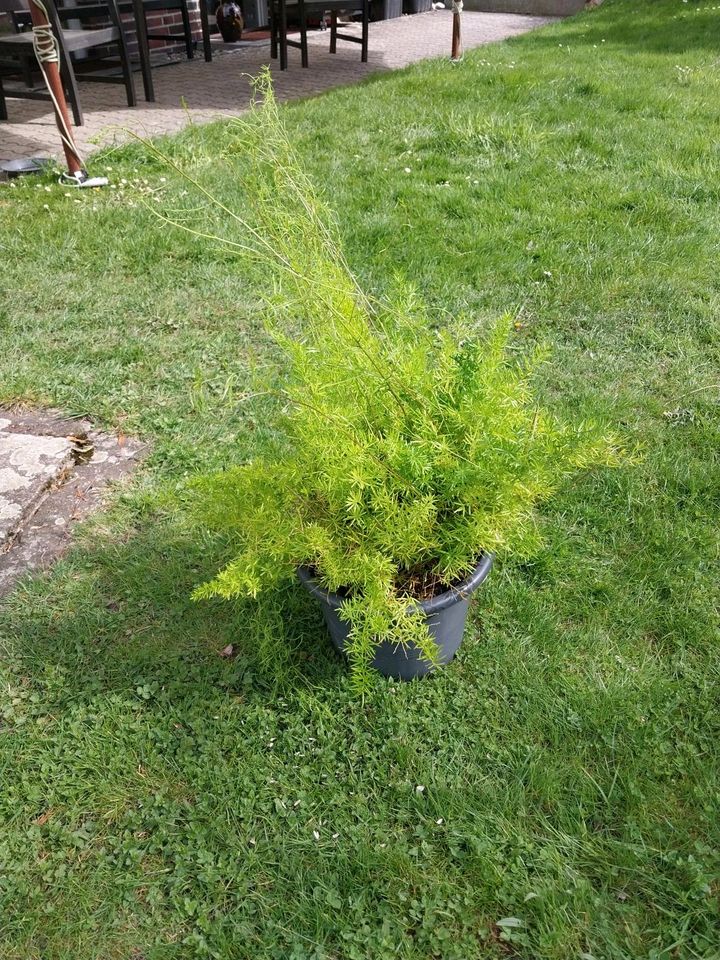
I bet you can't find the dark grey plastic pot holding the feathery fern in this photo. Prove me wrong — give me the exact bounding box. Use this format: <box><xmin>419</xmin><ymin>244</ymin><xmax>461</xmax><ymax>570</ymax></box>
<box><xmin>298</xmin><ymin>553</ymin><xmax>493</xmax><ymax>680</ymax></box>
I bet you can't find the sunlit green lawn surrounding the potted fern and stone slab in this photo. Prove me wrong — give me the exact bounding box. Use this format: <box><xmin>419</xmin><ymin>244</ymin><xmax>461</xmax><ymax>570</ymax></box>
<box><xmin>0</xmin><ymin>0</ymin><xmax>720</xmax><ymax>960</ymax></box>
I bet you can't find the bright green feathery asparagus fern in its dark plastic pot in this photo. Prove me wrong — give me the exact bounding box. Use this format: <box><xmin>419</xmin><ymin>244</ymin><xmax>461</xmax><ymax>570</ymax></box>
<box><xmin>190</xmin><ymin>78</ymin><xmax>617</xmax><ymax>688</ymax></box>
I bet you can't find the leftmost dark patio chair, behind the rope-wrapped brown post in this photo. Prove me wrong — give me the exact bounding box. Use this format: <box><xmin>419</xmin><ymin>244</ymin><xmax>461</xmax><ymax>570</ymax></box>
<box><xmin>0</xmin><ymin>0</ymin><xmax>137</xmax><ymax>126</ymax></box>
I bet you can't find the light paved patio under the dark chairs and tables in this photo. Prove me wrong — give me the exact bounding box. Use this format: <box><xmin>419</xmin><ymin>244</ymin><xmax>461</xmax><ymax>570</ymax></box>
<box><xmin>0</xmin><ymin>10</ymin><xmax>553</xmax><ymax>162</ymax></box>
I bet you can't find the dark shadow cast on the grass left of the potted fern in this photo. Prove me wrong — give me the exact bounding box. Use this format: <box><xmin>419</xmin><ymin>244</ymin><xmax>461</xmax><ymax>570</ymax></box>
<box><xmin>0</xmin><ymin>522</ymin><xmax>345</xmax><ymax>698</ymax></box>
